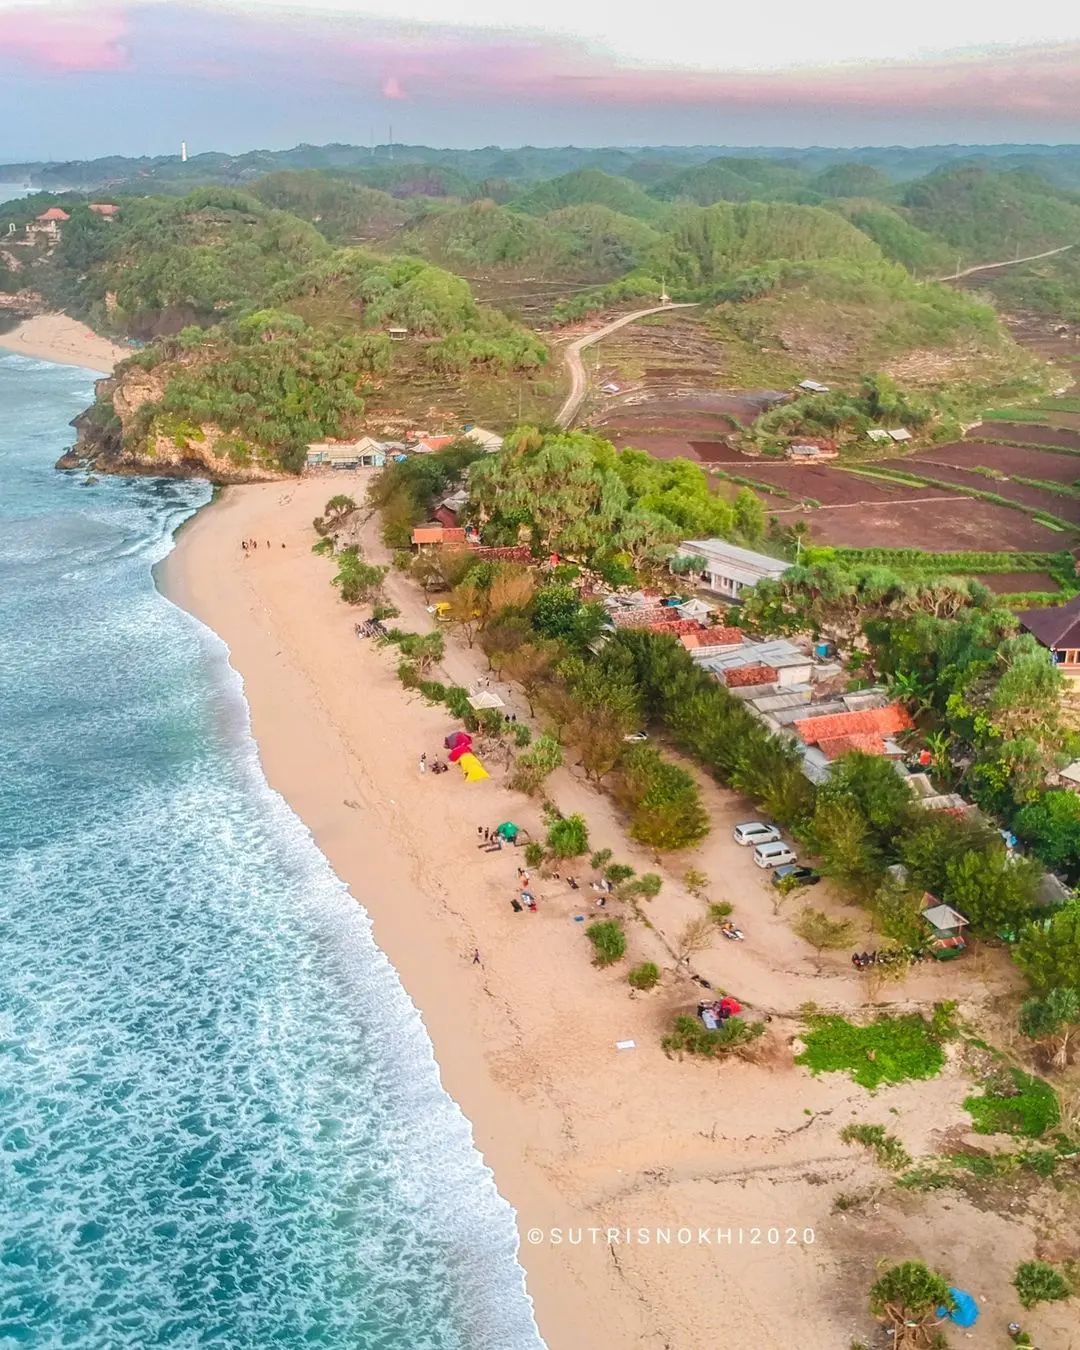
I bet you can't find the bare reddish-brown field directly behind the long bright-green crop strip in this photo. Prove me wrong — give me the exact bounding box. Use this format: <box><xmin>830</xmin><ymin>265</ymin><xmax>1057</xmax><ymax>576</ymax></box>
<box><xmin>799</xmin><ymin>499</ymin><xmax>1067</xmax><ymax>554</ymax></box>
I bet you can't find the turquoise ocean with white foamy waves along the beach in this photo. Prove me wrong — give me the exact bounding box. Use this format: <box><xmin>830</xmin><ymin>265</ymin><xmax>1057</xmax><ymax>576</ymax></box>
<box><xmin>0</xmin><ymin>355</ymin><xmax>541</xmax><ymax>1350</ymax></box>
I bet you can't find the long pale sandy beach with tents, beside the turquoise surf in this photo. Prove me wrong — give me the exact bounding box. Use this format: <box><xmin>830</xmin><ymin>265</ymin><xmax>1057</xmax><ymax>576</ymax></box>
<box><xmin>163</xmin><ymin>474</ymin><xmax>1069</xmax><ymax>1350</ymax></box>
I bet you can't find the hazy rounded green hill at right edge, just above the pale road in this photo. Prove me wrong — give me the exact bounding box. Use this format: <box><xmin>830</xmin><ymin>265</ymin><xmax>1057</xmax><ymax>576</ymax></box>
<box><xmin>905</xmin><ymin>167</ymin><xmax>1080</xmax><ymax>265</ymax></box>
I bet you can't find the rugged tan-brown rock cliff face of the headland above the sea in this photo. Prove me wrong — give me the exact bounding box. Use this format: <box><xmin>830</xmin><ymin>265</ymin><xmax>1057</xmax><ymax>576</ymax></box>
<box><xmin>57</xmin><ymin>366</ymin><xmax>290</xmax><ymax>483</ymax></box>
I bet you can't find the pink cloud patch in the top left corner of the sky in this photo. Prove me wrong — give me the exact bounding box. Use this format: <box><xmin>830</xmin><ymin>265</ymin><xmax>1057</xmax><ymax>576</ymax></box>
<box><xmin>0</xmin><ymin>9</ymin><xmax>128</xmax><ymax>73</ymax></box>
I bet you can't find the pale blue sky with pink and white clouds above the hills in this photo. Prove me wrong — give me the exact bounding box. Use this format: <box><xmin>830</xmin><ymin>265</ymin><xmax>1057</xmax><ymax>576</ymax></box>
<box><xmin>0</xmin><ymin>0</ymin><xmax>1080</xmax><ymax>161</ymax></box>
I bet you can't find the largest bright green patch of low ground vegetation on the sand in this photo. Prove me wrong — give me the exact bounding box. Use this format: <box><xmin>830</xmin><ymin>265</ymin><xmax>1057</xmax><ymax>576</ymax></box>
<box><xmin>795</xmin><ymin>1013</ymin><xmax>950</xmax><ymax>1091</ymax></box>
